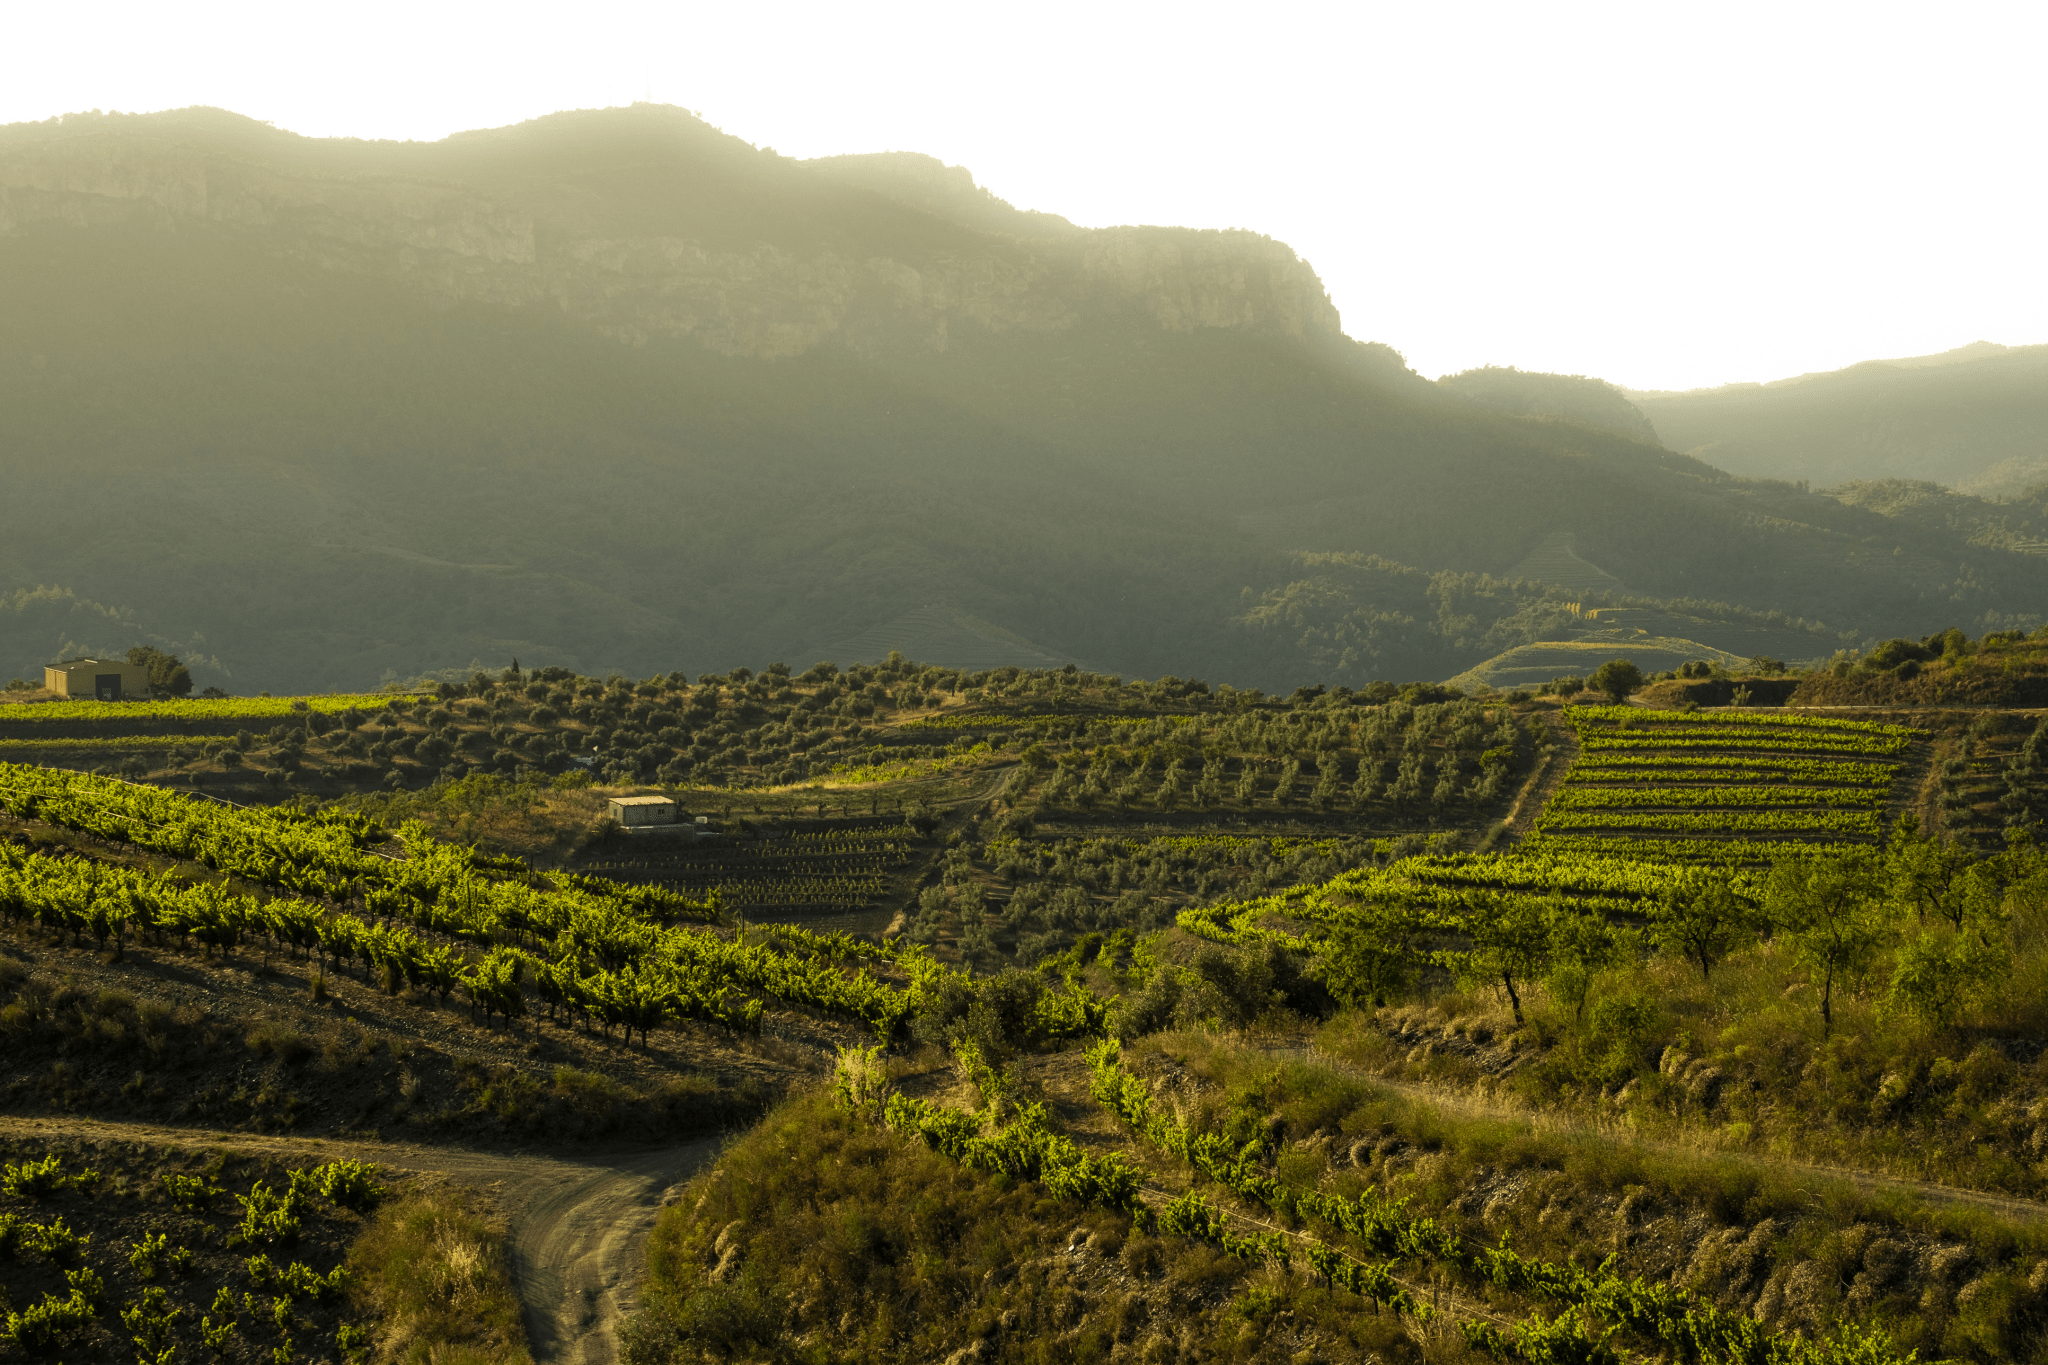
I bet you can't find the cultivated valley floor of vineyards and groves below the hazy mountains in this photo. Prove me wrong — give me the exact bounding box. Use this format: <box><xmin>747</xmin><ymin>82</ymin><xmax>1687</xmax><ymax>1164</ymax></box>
<box><xmin>0</xmin><ymin>636</ymin><xmax>2048</xmax><ymax>1365</ymax></box>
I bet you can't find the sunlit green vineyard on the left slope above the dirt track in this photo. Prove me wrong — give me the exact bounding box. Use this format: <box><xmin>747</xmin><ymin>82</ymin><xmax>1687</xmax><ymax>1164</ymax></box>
<box><xmin>0</xmin><ymin>765</ymin><xmax>974</xmax><ymax>1038</ymax></box>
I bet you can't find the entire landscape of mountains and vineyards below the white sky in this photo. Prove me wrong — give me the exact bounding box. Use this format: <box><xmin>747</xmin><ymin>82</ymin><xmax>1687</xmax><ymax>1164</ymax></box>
<box><xmin>0</xmin><ymin>82</ymin><xmax>2048</xmax><ymax>1365</ymax></box>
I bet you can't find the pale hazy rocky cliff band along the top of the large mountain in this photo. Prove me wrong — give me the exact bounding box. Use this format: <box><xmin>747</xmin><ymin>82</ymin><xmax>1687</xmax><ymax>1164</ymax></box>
<box><xmin>0</xmin><ymin>108</ymin><xmax>1339</xmax><ymax>356</ymax></box>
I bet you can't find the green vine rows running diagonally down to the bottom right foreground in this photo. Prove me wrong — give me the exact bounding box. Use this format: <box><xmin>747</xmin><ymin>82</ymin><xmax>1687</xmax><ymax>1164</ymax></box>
<box><xmin>811</xmin><ymin>1040</ymin><xmax>1915</xmax><ymax>1365</ymax></box>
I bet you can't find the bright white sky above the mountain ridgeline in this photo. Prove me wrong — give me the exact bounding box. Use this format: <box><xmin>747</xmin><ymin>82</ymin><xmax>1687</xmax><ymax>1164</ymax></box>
<box><xmin>0</xmin><ymin>0</ymin><xmax>2048</xmax><ymax>389</ymax></box>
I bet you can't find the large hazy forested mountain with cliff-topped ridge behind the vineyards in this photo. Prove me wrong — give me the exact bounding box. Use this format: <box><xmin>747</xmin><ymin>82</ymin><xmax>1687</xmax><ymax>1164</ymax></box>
<box><xmin>0</xmin><ymin>106</ymin><xmax>2048</xmax><ymax>690</ymax></box>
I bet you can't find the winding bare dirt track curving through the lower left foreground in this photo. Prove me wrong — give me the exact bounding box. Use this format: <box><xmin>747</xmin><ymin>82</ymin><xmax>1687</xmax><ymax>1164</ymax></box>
<box><xmin>0</xmin><ymin>1115</ymin><xmax>725</xmax><ymax>1365</ymax></box>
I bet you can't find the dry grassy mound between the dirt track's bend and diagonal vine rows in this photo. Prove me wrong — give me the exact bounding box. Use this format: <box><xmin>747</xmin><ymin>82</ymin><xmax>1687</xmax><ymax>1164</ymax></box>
<box><xmin>621</xmin><ymin>1088</ymin><xmax>1449</xmax><ymax>1365</ymax></box>
